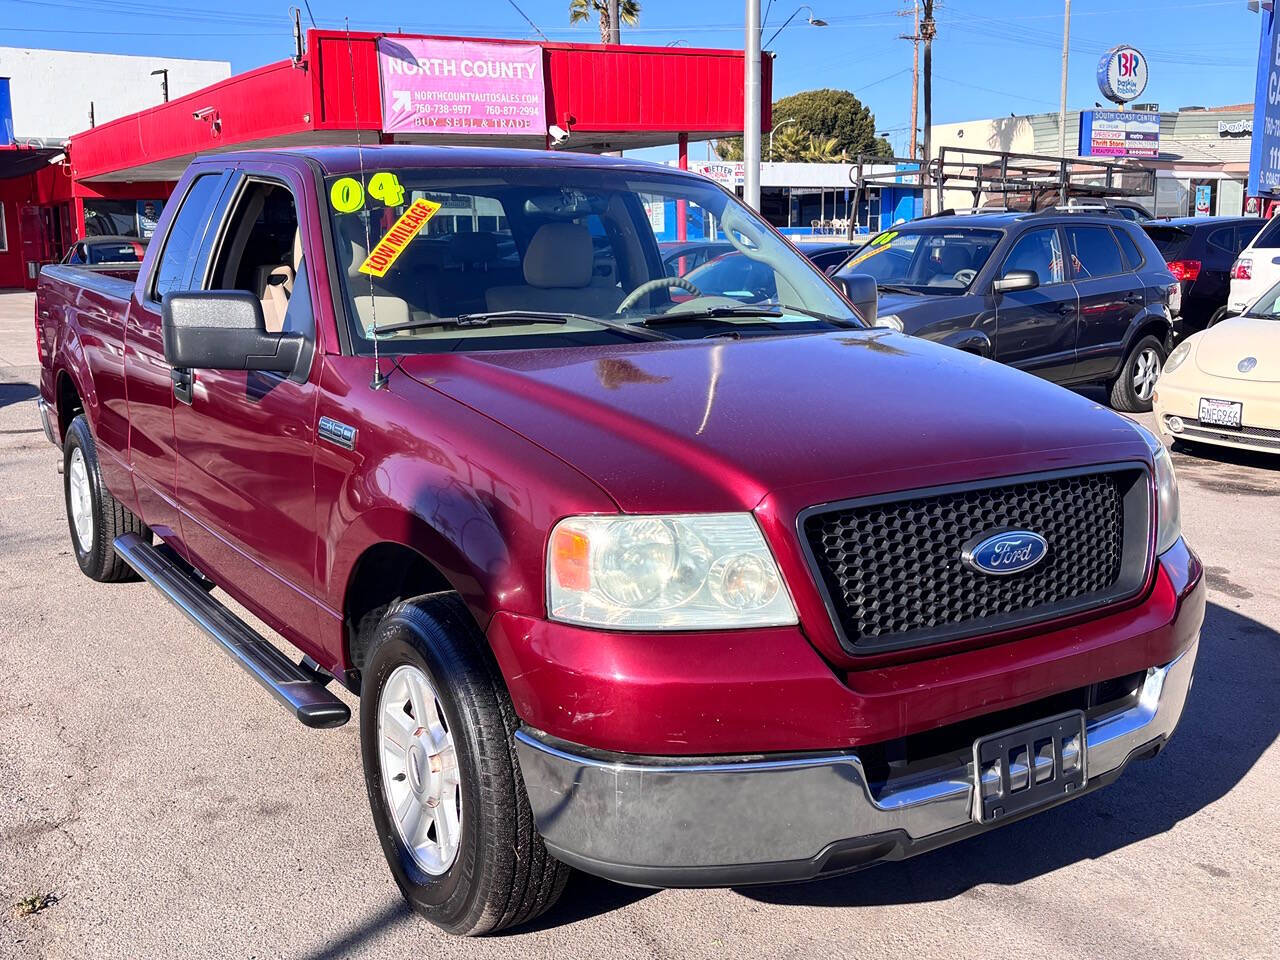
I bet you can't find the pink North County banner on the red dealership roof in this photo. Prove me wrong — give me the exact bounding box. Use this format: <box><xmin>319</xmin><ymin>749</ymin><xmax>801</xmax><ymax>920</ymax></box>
<box><xmin>378</xmin><ymin>37</ymin><xmax>547</xmax><ymax>136</ymax></box>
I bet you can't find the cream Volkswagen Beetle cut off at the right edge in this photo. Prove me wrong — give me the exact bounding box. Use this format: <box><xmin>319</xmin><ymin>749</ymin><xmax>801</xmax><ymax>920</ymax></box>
<box><xmin>1152</xmin><ymin>285</ymin><xmax>1280</xmax><ymax>453</ymax></box>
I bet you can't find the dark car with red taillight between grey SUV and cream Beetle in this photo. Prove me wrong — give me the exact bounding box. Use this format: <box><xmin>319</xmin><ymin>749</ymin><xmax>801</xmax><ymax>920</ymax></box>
<box><xmin>1142</xmin><ymin>216</ymin><xmax>1262</xmax><ymax>339</ymax></box>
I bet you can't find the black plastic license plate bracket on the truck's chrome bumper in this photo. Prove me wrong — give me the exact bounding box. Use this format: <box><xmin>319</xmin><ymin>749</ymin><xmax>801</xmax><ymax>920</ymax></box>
<box><xmin>973</xmin><ymin>710</ymin><xmax>1088</xmax><ymax>823</ymax></box>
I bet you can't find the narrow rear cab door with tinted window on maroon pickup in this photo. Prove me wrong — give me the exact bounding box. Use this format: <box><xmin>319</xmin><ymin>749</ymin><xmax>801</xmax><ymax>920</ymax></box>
<box><xmin>124</xmin><ymin>166</ymin><xmax>228</xmax><ymax>552</ymax></box>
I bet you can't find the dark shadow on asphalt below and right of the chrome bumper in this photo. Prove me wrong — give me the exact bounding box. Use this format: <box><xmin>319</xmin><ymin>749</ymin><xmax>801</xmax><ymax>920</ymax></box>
<box><xmin>739</xmin><ymin>603</ymin><xmax>1280</xmax><ymax>906</ymax></box>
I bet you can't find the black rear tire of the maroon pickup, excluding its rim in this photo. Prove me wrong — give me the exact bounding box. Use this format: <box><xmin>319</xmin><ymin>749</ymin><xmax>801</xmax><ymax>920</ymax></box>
<box><xmin>63</xmin><ymin>413</ymin><xmax>151</xmax><ymax>584</ymax></box>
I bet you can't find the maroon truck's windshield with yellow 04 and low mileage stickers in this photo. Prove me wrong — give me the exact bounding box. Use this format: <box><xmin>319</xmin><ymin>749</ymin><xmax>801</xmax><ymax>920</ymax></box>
<box><xmin>326</xmin><ymin>165</ymin><xmax>863</xmax><ymax>353</ymax></box>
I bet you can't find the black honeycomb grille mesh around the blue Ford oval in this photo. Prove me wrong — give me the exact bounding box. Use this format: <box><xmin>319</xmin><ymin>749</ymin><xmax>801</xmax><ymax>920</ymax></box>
<box><xmin>804</xmin><ymin>472</ymin><xmax>1132</xmax><ymax>648</ymax></box>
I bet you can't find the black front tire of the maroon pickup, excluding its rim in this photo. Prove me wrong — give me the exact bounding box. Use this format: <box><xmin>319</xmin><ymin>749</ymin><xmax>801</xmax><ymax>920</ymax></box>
<box><xmin>360</xmin><ymin>594</ymin><xmax>570</xmax><ymax>936</ymax></box>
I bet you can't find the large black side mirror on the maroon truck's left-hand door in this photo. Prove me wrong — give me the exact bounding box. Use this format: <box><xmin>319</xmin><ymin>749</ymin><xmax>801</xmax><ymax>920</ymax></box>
<box><xmin>160</xmin><ymin>291</ymin><xmax>306</xmax><ymax>374</ymax></box>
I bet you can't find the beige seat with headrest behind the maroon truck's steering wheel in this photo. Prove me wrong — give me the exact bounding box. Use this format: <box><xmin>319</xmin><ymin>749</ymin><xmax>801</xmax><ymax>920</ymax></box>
<box><xmin>485</xmin><ymin>223</ymin><xmax>623</xmax><ymax>316</ymax></box>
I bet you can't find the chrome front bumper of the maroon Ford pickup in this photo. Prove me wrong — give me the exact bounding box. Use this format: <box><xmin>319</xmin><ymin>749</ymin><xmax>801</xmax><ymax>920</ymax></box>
<box><xmin>516</xmin><ymin>641</ymin><xmax>1198</xmax><ymax>887</ymax></box>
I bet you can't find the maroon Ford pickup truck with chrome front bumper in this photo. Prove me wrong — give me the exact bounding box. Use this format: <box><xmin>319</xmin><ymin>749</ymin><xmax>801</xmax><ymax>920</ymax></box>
<box><xmin>36</xmin><ymin>146</ymin><xmax>1204</xmax><ymax>933</ymax></box>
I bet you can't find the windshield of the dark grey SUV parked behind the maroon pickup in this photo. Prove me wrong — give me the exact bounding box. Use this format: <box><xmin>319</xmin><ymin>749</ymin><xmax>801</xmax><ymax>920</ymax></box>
<box><xmin>840</xmin><ymin>229</ymin><xmax>1001</xmax><ymax>293</ymax></box>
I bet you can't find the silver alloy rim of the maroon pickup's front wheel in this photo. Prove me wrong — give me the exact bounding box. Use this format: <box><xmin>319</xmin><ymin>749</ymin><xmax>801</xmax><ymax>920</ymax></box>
<box><xmin>378</xmin><ymin>663</ymin><xmax>462</xmax><ymax>877</ymax></box>
